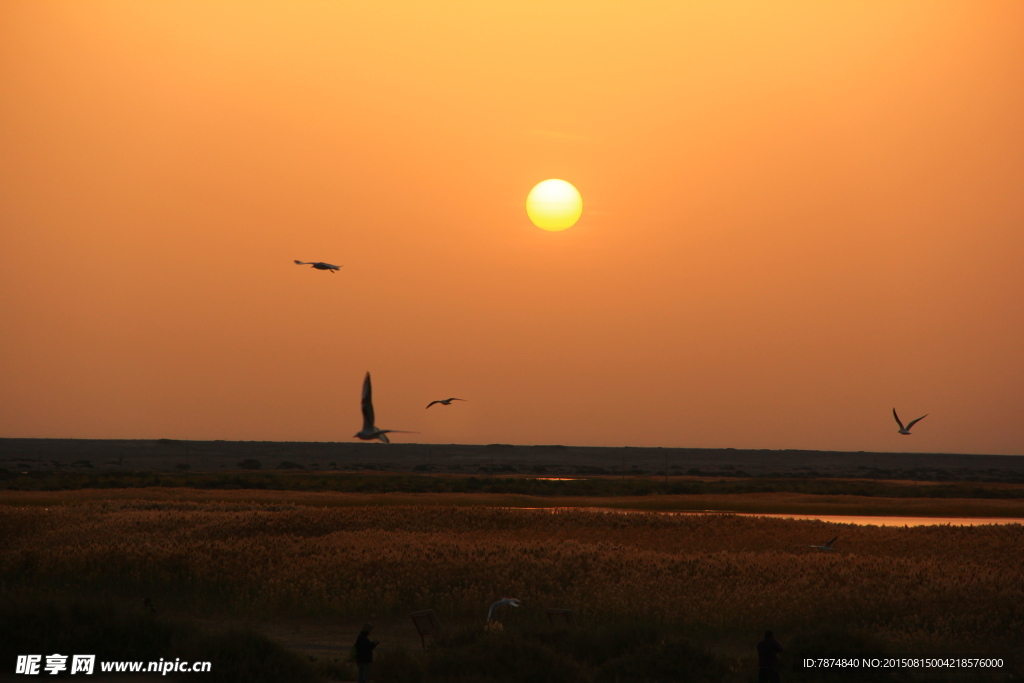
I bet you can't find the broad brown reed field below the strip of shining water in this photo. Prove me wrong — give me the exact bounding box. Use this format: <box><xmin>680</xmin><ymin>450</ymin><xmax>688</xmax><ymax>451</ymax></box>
<box><xmin>0</xmin><ymin>492</ymin><xmax>1024</xmax><ymax>681</ymax></box>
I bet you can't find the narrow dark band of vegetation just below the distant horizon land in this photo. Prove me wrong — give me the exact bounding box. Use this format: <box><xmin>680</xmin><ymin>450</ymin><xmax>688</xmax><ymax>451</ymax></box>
<box><xmin>6</xmin><ymin>469</ymin><xmax>1024</xmax><ymax>500</ymax></box>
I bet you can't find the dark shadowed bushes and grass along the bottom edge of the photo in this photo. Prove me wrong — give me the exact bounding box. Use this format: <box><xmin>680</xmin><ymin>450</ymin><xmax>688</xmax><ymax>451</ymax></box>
<box><xmin>0</xmin><ymin>600</ymin><xmax>1011</xmax><ymax>683</ymax></box>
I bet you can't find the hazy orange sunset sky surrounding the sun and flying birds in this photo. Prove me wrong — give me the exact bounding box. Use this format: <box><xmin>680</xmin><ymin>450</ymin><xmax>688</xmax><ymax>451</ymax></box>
<box><xmin>0</xmin><ymin>0</ymin><xmax>1024</xmax><ymax>454</ymax></box>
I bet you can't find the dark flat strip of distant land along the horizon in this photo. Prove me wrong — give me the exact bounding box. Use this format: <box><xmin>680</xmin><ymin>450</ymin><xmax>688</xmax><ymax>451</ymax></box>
<box><xmin>0</xmin><ymin>438</ymin><xmax>1024</xmax><ymax>483</ymax></box>
